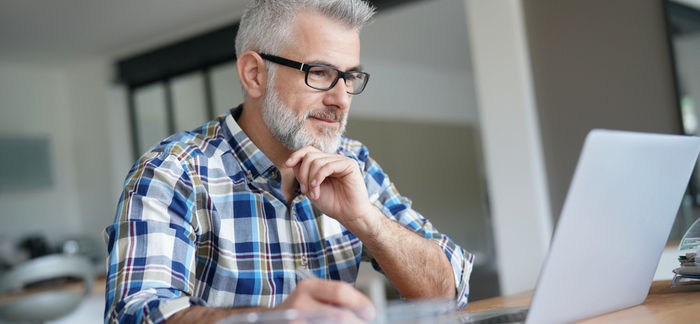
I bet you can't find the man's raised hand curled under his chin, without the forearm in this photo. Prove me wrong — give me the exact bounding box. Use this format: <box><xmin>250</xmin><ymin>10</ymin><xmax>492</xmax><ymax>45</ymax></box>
<box><xmin>285</xmin><ymin>146</ymin><xmax>379</xmax><ymax>235</ymax></box>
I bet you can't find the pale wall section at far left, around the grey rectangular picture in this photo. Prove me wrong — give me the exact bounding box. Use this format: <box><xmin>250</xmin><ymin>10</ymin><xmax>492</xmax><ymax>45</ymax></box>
<box><xmin>0</xmin><ymin>62</ymin><xmax>82</xmax><ymax>239</ymax></box>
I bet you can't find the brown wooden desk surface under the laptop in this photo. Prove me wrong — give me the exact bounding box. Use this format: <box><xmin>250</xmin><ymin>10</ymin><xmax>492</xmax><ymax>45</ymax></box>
<box><xmin>466</xmin><ymin>280</ymin><xmax>700</xmax><ymax>324</ymax></box>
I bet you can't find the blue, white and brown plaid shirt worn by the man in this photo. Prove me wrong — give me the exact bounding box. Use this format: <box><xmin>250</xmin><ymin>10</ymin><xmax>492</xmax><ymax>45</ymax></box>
<box><xmin>105</xmin><ymin>108</ymin><xmax>473</xmax><ymax>323</ymax></box>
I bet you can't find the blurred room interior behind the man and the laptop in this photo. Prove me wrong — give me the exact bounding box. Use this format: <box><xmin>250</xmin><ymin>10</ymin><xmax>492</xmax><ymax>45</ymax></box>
<box><xmin>0</xmin><ymin>0</ymin><xmax>700</xmax><ymax>323</ymax></box>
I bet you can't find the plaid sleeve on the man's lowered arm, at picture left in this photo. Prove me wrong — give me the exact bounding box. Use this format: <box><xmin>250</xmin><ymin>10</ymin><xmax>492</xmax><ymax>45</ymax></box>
<box><xmin>104</xmin><ymin>153</ymin><xmax>204</xmax><ymax>323</ymax></box>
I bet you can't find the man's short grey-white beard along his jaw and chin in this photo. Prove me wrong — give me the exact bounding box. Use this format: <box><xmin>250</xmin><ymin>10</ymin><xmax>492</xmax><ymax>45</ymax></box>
<box><xmin>262</xmin><ymin>83</ymin><xmax>347</xmax><ymax>153</ymax></box>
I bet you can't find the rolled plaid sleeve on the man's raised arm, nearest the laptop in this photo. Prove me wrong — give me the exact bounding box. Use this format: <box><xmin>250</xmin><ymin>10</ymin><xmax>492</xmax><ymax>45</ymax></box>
<box><xmin>357</xmin><ymin>146</ymin><xmax>474</xmax><ymax>309</ymax></box>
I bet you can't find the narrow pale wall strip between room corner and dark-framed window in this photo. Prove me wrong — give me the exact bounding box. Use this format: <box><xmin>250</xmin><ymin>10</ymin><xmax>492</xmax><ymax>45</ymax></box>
<box><xmin>63</xmin><ymin>58</ymin><xmax>133</xmax><ymax>250</ymax></box>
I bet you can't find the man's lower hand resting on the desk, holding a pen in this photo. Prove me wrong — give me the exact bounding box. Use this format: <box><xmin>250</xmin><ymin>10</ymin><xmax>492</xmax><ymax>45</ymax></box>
<box><xmin>277</xmin><ymin>279</ymin><xmax>376</xmax><ymax>323</ymax></box>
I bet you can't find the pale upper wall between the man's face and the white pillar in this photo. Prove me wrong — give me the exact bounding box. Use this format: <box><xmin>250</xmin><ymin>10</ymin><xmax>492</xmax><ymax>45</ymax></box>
<box><xmin>351</xmin><ymin>0</ymin><xmax>478</xmax><ymax>125</ymax></box>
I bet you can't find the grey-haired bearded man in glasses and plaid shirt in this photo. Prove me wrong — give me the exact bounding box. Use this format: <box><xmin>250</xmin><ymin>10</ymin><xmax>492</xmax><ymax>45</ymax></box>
<box><xmin>105</xmin><ymin>0</ymin><xmax>473</xmax><ymax>323</ymax></box>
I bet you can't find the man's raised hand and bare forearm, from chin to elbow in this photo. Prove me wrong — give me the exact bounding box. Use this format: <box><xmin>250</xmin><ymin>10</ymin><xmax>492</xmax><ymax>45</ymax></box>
<box><xmin>285</xmin><ymin>146</ymin><xmax>456</xmax><ymax>298</ymax></box>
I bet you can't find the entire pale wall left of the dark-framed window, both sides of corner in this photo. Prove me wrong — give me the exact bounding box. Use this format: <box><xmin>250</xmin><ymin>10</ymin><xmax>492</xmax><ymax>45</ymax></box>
<box><xmin>0</xmin><ymin>58</ymin><xmax>132</xmax><ymax>253</ymax></box>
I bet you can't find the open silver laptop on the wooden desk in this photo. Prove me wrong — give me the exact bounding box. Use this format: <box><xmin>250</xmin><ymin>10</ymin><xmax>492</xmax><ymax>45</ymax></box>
<box><xmin>463</xmin><ymin>130</ymin><xmax>700</xmax><ymax>324</ymax></box>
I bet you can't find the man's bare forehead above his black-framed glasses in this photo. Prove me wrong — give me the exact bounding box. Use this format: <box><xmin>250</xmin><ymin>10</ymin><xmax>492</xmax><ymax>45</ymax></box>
<box><xmin>283</xmin><ymin>11</ymin><xmax>360</xmax><ymax>69</ymax></box>
